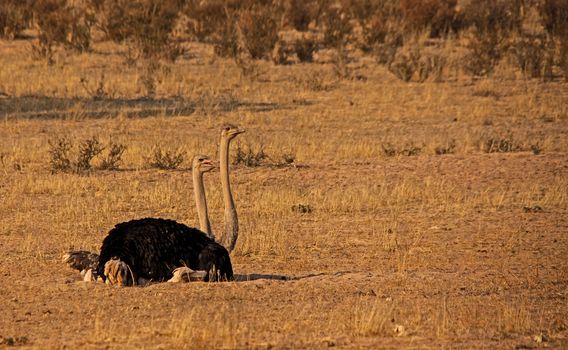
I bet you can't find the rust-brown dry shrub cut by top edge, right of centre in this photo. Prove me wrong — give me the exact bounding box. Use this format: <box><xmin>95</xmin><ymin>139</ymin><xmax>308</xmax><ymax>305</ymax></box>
<box><xmin>400</xmin><ymin>0</ymin><xmax>457</xmax><ymax>36</ymax></box>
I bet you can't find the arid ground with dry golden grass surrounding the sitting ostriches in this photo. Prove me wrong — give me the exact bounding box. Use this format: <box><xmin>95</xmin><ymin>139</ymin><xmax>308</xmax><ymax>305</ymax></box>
<box><xmin>0</xmin><ymin>33</ymin><xmax>568</xmax><ymax>349</ymax></box>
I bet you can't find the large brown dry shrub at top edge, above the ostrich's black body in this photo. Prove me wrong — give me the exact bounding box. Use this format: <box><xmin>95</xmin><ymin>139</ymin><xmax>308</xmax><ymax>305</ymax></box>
<box><xmin>92</xmin><ymin>0</ymin><xmax>183</xmax><ymax>60</ymax></box>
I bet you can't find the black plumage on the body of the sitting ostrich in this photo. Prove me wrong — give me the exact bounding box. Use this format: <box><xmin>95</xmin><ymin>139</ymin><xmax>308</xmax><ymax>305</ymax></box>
<box><xmin>97</xmin><ymin>218</ymin><xmax>233</xmax><ymax>281</ymax></box>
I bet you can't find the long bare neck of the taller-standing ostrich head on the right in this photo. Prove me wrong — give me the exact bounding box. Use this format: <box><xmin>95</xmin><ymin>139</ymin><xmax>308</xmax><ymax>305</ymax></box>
<box><xmin>219</xmin><ymin>137</ymin><xmax>239</xmax><ymax>252</ymax></box>
